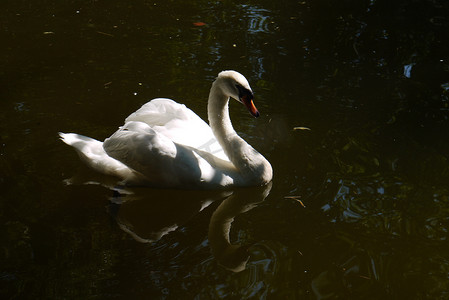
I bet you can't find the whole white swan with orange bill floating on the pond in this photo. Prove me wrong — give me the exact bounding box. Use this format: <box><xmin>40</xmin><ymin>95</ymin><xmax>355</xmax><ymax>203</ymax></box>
<box><xmin>59</xmin><ymin>71</ymin><xmax>273</xmax><ymax>189</ymax></box>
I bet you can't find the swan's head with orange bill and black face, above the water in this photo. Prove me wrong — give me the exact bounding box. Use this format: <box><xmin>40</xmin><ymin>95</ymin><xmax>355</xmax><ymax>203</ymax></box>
<box><xmin>215</xmin><ymin>71</ymin><xmax>260</xmax><ymax>118</ymax></box>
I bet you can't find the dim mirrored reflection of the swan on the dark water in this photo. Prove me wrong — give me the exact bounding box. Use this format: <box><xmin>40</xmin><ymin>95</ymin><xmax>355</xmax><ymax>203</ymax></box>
<box><xmin>110</xmin><ymin>183</ymin><xmax>272</xmax><ymax>272</ymax></box>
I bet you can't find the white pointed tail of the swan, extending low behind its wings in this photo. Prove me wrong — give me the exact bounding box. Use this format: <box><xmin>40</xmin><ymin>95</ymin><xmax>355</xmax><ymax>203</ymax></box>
<box><xmin>59</xmin><ymin>132</ymin><xmax>142</xmax><ymax>182</ymax></box>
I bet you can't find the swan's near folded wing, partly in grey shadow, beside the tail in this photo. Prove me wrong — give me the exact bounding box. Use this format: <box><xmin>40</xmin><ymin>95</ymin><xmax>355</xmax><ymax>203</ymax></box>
<box><xmin>103</xmin><ymin>121</ymin><xmax>202</xmax><ymax>187</ymax></box>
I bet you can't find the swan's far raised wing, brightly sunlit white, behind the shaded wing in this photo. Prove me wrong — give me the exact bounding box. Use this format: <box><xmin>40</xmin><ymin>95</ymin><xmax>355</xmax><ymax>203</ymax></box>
<box><xmin>125</xmin><ymin>98</ymin><xmax>229</xmax><ymax>161</ymax></box>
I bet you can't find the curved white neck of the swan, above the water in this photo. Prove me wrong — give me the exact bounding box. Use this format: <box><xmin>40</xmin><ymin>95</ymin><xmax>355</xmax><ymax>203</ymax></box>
<box><xmin>207</xmin><ymin>82</ymin><xmax>273</xmax><ymax>185</ymax></box>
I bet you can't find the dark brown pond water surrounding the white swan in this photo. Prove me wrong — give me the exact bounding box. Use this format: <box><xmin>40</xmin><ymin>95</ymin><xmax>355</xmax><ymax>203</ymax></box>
<box><xmin>0</xmin><ymin>0</ymin><xmax>449</xmax><ymax>299</ymax></box>
